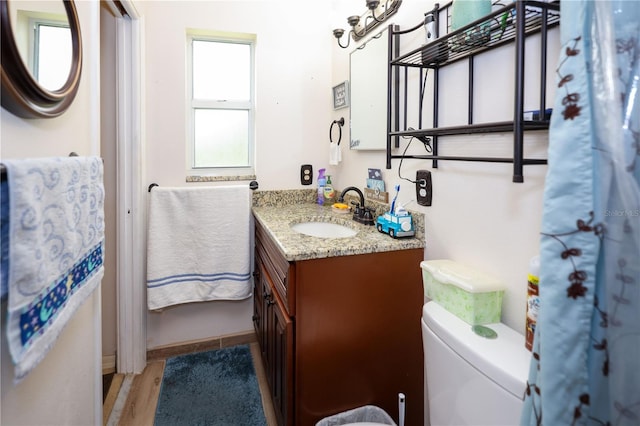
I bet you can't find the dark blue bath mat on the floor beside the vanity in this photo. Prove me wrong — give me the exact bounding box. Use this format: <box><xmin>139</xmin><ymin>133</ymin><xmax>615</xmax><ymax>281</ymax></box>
<box><xmin>155</xmin><ymin>345</ymin><xmax>267</xmax><ymax>426</ymax></box>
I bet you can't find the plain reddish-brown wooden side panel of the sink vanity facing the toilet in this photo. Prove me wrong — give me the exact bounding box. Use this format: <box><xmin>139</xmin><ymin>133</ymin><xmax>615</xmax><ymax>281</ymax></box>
<box><xmin>294</xmin><ymin>249</ymin><xmax>424</xmax><ymax>426</ymax></box>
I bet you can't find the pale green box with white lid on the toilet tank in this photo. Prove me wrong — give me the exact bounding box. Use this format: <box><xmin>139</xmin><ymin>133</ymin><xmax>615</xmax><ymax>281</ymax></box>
<box><xmin>420</xmin><ymin>260</ymin><xmax>505</xmax><ymax>325</ymax></box>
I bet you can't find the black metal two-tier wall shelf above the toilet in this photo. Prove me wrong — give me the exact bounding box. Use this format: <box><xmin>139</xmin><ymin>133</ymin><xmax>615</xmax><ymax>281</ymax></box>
<box><xmin>387</xmin><ymin>0</ymin><xmax>560</xmax><ymax>182</ymax></box>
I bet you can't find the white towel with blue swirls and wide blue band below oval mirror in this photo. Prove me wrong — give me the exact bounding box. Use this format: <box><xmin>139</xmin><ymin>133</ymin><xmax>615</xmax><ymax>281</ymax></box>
<box><xmin>4</xmin><ymin>157</ymin><xmax>104</xmax><ymax>383</ymax></box>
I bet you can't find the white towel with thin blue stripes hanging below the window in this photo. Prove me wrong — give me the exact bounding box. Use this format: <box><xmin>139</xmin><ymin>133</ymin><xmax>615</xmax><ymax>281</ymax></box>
<box><xmin>147</xmin><ymin>185</ymin><xmax>252</xmax><ymax>310</ymax></box>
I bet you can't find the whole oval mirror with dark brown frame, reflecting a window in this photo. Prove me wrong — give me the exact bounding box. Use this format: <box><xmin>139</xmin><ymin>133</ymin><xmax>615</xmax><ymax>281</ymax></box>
<box><xmin>0</xmin><ymin>0</ymin><xmax>82</xmax><ymax>118</ymax></box>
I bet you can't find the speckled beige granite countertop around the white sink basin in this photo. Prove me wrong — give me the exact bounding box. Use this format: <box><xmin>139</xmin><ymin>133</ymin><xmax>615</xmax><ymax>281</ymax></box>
<box><xmin>252</xmin><ymin>190</ymin><xmax>425</xmax><ymax>261</ymax></box>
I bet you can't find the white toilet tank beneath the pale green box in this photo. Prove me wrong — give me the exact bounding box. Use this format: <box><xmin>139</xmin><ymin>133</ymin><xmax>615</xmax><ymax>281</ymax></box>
<box><xmin>422</xmin><ymin>302</ymin><xmax>531</xmax><ymax>426</ymax></box>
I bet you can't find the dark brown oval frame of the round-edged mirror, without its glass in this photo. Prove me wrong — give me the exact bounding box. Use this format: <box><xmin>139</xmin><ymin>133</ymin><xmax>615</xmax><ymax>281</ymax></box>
<box><xmin>0</xmin><ymin>0</ymin><xmax>82</xmax><ymax>118</ymax></box>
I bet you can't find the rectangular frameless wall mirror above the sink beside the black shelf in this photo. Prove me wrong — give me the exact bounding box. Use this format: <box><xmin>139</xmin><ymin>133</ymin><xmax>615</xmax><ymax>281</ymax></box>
<box><xmin>349</xmin><ymin>29</ymin><xmax>389</xmax><ymax>150</ymax></box>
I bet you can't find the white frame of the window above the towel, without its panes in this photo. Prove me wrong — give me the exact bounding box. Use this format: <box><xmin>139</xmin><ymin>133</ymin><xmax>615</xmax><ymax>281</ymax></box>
<box><xmin>186</xmin><ymin>30</ymin><xmax>256</xmax><ymax>179</ymax></box>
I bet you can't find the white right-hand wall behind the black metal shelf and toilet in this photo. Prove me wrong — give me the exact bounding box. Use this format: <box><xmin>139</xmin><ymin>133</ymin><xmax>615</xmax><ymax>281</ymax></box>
<box><xmin>325</xmin><ymin>0</ymin><xmax>559</xmax><ymax>334</ymax></box>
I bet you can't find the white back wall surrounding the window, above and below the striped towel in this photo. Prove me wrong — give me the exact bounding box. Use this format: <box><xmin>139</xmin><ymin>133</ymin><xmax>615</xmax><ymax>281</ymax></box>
<box><xmin>140</xmin><ymin>0</ymin><xmax>333</xmax><ymax>348</ymax></box>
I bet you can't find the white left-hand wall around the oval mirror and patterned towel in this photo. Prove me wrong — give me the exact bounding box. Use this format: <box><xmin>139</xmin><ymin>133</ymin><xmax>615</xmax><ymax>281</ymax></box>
<box><xmin>0</xmin><ymin>1</ymin><xmax>102</xmax><ymax>425</ymax></box>
